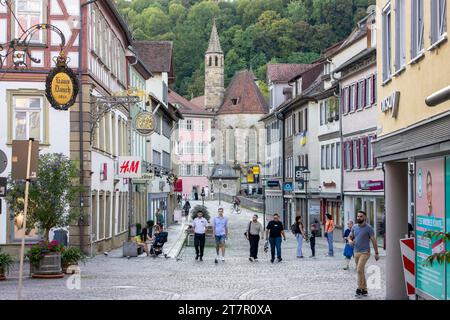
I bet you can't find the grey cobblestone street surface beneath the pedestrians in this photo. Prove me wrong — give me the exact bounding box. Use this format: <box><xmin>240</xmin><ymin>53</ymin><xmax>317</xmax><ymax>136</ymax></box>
<box><xmin>0</xmin><ymin>201</ymin><xmax>385</xmax><ymax>300</ymax></box>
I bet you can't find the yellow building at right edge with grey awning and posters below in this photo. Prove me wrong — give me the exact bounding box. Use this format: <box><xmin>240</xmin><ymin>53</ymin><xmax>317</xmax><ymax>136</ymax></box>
<box><xmin>374</xmin><ymin>0</ymin><xmax>450</xmax><ymax>299</ymax></box>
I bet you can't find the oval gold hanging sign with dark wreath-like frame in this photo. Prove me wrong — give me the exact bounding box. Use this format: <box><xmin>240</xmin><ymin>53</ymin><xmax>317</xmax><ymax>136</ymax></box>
<box><xmin>45</xmin><ymin>53</ymin><xmax>78</xmax><ymax>110</ymax></box>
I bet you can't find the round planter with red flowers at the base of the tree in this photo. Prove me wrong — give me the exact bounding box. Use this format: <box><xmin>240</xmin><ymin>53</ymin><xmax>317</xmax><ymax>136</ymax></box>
<box><xmin>27</xmin><ymin>240</ymin><xmax>64</xmax><ymax>278</ymax></box>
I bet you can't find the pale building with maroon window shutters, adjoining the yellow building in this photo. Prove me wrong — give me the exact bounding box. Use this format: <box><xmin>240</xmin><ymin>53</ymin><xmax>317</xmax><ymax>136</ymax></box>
<box><xmin>334</xmin><ymin>16</ymin><xmax>386</xmax><ymax>247</ymax></box>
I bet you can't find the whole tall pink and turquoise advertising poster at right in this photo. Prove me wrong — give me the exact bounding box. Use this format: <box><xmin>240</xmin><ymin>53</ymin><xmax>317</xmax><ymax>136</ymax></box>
<box><xmin>416</xmin><ymin>158</ymin><xmax>445</xmax><ymax>300</ymax></box>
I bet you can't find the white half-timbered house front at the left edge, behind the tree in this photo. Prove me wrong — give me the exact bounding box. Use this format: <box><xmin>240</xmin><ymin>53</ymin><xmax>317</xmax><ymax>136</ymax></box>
<box><xmin>0</xmin><ymin>0</ymin><xmax>80</xmax><ymax>252</ymax></box>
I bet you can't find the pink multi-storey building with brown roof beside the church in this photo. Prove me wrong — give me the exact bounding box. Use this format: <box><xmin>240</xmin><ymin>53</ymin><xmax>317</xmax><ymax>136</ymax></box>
<box><xmin>169</xmin><ymin>90</ymin><xmax>214</xmax><ymax>199</ymax></box>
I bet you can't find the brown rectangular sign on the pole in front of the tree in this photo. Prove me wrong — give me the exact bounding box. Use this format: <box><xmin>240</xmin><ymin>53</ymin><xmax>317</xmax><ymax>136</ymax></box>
<box><xmin>11</xmin><ymin>140</ymin><xmax>39</xmax><ymax>180</ymax></box>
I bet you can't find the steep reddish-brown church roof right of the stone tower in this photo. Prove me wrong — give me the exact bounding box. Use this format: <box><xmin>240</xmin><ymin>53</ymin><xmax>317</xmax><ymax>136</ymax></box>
<box><xmin>217</xmin><ymin>70</ymin><xmax>269</xmax><ymax>114</ymax></box>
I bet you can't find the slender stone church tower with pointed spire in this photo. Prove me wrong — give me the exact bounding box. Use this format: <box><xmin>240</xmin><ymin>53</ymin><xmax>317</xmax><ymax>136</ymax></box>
<box><xmin>205</xmin><ymin>20</ymin><xmax>225</xmax><ymax>112</ymax></box>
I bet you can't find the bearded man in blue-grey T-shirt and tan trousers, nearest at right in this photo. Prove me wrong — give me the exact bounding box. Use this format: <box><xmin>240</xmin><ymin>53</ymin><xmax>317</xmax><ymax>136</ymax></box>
<box><xmin>348</xmin><ymin>210</ymin><xmax>380</xmax><ymax>297</ymax></box>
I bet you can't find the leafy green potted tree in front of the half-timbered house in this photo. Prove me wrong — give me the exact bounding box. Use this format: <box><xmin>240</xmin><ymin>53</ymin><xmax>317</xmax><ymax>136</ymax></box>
<box><xmin>6</xmin><ymin>153</ymin><xmax>81</xmax><ymax>240</ymax></box>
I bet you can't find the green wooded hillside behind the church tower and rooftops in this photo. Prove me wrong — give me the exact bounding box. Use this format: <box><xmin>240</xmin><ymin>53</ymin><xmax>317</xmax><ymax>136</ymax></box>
<box><xmin>116</xmin><ymin>0</ymin><xmax>375</xmax><ymax>98</ymax></box>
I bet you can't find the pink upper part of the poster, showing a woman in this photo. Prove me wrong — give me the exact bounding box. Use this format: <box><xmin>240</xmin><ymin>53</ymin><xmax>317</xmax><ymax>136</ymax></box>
<box><xmin>416</xmin><ymin>158</ymin><xmax>445</xmax><ymax>218</ymax></box>
